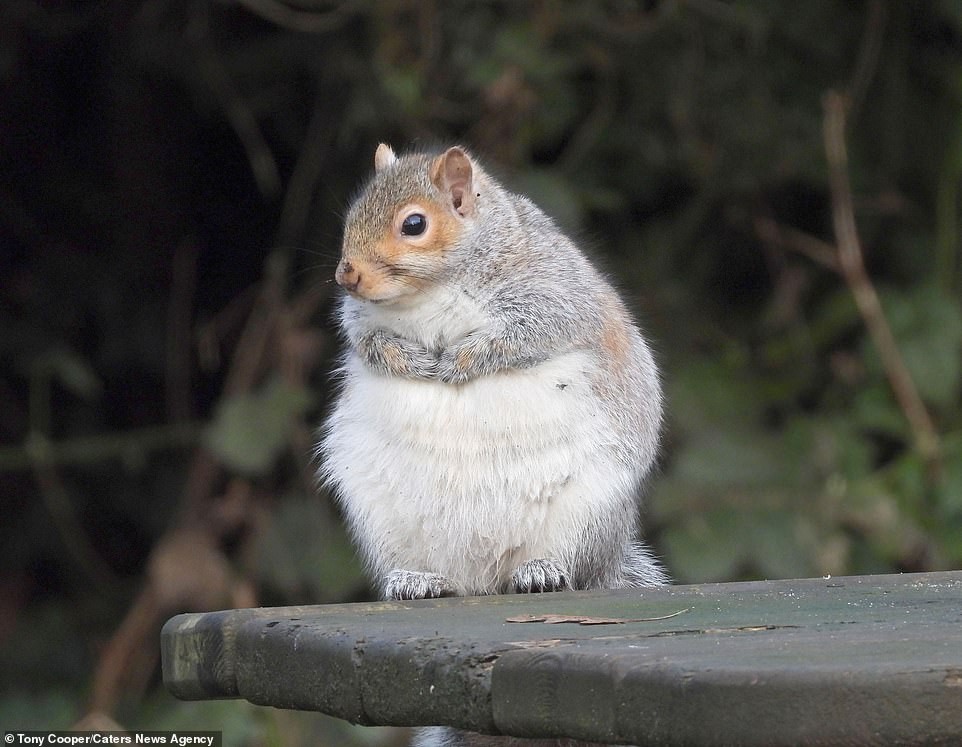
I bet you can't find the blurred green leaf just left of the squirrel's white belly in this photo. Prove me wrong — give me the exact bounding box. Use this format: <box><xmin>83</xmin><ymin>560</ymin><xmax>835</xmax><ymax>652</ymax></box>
<box><xmin>205</xmin><ymin>379</ymin><xmax>313</xmax><ymax>475</ymax></box>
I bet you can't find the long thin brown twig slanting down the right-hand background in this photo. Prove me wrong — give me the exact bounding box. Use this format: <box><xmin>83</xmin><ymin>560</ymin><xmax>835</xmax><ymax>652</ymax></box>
<box><xmin>823</xmin><ymin>91</ymin><xmax>940</xmax><ymax>473</ymax></box>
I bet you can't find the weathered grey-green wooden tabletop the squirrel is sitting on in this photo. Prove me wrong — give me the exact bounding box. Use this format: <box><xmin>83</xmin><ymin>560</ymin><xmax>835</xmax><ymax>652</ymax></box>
<box><xmin>162</xmin><ymin>571</ymin><xmax>962</xmax><ymax>745</ymax></box>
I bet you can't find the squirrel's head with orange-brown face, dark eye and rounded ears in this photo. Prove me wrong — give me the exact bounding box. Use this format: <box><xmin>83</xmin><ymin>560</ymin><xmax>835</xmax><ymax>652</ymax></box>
<box><xmin>334</xmin><ymin>143</ymin><xmax>478</xmax><ymax>303</ymax></box>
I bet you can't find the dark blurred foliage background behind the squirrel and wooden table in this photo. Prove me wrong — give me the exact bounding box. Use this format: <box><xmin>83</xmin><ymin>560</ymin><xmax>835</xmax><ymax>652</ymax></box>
<box><xmin>0</xmin><ymin>0</ymin><xmax>962</xmax><ymax>745</ymax></box>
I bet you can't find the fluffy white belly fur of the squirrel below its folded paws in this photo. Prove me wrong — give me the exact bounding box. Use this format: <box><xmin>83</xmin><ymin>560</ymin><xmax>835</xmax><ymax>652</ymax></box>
<box><xmin>322</xmin><ymin>353</ymin><xmax>632</xmax><ymax>593</ymax></box>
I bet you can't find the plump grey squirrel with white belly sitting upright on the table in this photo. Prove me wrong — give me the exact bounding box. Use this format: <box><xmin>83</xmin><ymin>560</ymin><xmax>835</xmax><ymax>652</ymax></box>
<box><xmin>318</xmin><ymin>144</ymin><xmax>667</xmax><ymax>744</ymax></box>
